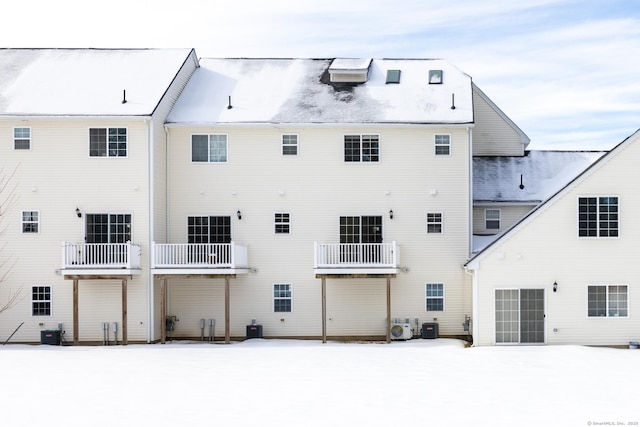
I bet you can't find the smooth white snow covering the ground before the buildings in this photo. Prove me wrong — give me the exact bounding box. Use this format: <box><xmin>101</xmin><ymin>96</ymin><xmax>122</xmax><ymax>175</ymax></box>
<box><xmin>0</xmin><ymin>339</ymin><xmax>640</xmax><ymax>427</ymax></box>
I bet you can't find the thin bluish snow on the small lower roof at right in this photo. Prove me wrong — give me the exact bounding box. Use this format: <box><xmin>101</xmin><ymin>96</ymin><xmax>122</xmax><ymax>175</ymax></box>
<box><xmin>473</xmin><ymin>150</ymin><xmax>606</xmax><ymax>204</ymax></box>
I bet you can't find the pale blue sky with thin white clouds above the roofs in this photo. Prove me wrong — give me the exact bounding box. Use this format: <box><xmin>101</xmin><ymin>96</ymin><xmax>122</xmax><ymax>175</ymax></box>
<box><xmin>0</xmin><ymin>0</ymin><xmax>640</xmax><ymax>150</ymax></box>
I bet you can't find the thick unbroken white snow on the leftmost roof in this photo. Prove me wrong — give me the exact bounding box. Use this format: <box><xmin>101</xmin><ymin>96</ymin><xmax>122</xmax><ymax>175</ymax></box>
<box><xmin>0</xmin><ymin>49</ymin><xmax>192</xmax><ymax>116</ymax></box>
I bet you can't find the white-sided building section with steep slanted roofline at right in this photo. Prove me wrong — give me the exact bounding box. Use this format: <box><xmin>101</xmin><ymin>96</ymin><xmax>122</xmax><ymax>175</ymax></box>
<box><xmin>467</xmin><ymin>132</ymin><xmax>640</xmax><ymax>346</ymax></box>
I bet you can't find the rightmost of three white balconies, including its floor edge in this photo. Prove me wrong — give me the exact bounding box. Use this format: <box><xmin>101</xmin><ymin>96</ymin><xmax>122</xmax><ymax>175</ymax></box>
<box><xmin>313</xmin><ymin>242</ymin><xmax>400</xmax><ymax>275</ymax></box>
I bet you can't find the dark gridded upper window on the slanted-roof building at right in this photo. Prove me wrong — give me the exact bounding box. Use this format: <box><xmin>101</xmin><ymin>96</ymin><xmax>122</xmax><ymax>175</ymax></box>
<box><xmin>578</xmin><ymin>197</ymin><xmax>619</xmax><ymax>237</ymax></box>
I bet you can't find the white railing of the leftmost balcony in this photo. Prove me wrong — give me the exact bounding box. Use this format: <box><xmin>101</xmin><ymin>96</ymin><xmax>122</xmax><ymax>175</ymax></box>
<box><xmin>62</xmin><ymin>242</ymin><xmax>140</xmax><ymax>269</ymax></box>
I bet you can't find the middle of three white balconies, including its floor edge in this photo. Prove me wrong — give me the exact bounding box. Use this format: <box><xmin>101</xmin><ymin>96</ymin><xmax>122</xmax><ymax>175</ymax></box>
<box><xmin>151</xmin><ymin>242</ymin><xmax>249</xmax><ymax>275</ymax></box>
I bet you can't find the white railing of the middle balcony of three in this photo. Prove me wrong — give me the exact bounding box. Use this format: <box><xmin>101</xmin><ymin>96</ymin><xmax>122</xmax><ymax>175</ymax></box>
<box><xmin>152</xmin><ymin>242</ymin><xmax>248</xmax><ymax>268</ymax></box>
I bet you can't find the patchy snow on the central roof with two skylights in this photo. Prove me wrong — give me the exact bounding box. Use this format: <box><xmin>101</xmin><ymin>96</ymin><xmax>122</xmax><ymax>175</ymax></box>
<box><xmin>167</xmin><ymin>58</ymin><xmax>473</xmax><ymax>124</ymax></box>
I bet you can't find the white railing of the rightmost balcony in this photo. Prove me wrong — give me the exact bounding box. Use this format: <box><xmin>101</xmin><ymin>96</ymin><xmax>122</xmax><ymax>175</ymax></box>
<box><xmin>314</xmin><ymin>242</ymin><xmax>400</xmax><ymax>268</ymax></box>
